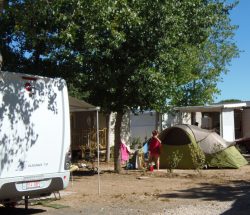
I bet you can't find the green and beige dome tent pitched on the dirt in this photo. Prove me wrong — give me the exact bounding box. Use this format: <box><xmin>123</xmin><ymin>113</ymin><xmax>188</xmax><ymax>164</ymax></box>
<box><xmin>159</xmin><ymin>124</ymin><xmax>248</xmax><ymax>169</ymax></box>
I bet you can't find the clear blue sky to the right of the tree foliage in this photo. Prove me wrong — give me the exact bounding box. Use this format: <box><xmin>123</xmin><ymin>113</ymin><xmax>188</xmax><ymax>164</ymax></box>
<box><xmin>215</xmin><ymin>0</ymin><xmax>250</xmax><ymax>102</ymax></box>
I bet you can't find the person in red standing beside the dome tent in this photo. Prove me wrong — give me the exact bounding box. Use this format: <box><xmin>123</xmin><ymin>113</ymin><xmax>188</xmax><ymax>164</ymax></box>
<box><xmin>149</xmin><ymin>130</ymin><xmax>161</xmax><ymax>170</ymax></box>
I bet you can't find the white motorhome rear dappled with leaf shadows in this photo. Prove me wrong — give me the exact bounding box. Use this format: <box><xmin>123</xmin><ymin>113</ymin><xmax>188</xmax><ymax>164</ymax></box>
<box><xmin>0</xmin><ymin>72</ymin><xmax>70</xmax><ymax>207</ymax></box>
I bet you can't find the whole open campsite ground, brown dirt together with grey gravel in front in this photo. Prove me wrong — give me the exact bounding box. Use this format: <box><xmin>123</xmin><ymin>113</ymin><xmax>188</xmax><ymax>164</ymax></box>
<box><xmin>3</xmin><ymin>164</ymin><xmax>250</xmax><ymax>215</ymax></box>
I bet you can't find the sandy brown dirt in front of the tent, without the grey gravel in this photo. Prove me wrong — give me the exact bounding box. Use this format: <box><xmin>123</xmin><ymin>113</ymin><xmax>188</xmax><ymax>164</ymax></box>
<box><xmin>52</xmin><ymin>164</ymin><xmax>250</xmax><ymax>214</ymax></box>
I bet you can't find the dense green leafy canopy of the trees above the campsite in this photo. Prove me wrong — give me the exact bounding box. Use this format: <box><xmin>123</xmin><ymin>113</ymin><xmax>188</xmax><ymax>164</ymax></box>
<box><xmin>0</xmin><ymin>0</ymin><xmax>238</xmax><ymax>171</ymax></box>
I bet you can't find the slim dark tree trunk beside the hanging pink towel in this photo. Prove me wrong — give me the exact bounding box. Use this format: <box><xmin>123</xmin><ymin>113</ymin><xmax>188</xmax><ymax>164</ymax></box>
<box><xmin>114</xmin><ymin>112</ymin><xmax>123</xmax><ymax>173</ymax></box>
